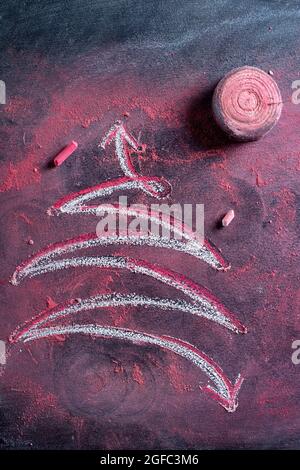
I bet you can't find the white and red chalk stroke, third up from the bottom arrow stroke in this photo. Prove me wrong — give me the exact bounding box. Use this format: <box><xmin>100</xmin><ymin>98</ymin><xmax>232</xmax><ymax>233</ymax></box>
<box><xmin>11</xmin><ymin>256</ymin><xmax>247</xmax><ymax>333</ymax></box>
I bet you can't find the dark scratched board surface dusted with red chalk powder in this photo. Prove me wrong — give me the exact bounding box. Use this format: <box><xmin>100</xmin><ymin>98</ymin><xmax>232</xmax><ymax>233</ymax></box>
<box><xmin>0</xmin><ymin>0</ymin><xmax>300</xmax><ymax>449</ymax></box>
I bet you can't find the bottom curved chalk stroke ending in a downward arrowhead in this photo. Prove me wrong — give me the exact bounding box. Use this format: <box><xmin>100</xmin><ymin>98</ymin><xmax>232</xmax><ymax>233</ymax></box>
<box><xmin>14</xmin><ymin>324</ymin><xmax>243</xmax><ymax>412</ymax></box>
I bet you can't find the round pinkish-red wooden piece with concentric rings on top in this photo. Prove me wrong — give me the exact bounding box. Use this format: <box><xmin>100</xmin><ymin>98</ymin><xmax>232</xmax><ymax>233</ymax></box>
<box><xmin>212</xmin><ymin>66</ymin><xmax>282</xmax><ymax>141</ymax></box>
